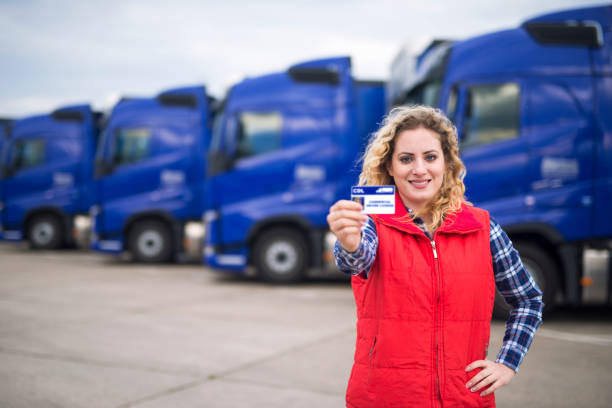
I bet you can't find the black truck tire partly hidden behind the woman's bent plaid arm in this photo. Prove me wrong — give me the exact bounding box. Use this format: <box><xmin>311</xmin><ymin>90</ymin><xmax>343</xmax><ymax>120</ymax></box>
<box><xmin>493</xmin><ymin>243</ymin><xmax>559</xmax><ymax>319</ymax></box>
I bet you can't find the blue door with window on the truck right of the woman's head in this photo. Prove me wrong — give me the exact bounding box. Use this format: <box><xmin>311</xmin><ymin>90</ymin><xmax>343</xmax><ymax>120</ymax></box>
<box><xmin>447</xmin><ymin>81</ymin><xmax>528</xmax><ymax>215</ymax></box>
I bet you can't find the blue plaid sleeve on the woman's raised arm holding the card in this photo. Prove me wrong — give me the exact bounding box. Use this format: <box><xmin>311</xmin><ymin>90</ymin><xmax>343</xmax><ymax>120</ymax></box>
<box><xmin>334</xmin><ymin>216</ymin><xmax>378</xmax><ymax>278</ymax></box>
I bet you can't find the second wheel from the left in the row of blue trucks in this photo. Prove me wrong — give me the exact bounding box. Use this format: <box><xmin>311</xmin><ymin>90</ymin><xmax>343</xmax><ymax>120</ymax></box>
<box><xmin>128</xmin><ymin>220</ymin><xmax>172</xmax><ymax>263</ymax></box>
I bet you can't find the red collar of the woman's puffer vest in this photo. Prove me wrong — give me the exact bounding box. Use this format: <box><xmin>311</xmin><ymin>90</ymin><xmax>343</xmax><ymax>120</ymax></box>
<box><xmin>372</xmin><ymin>188</ymin><xmax>483</xmax><ymax>236</ymax></box>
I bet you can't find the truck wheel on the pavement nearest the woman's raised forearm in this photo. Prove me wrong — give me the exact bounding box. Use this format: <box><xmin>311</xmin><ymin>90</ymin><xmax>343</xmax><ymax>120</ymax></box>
<box><xmin>253</xmin><ymin>228</ymin><xmax>307</xmax><ymax>283</ymax></box>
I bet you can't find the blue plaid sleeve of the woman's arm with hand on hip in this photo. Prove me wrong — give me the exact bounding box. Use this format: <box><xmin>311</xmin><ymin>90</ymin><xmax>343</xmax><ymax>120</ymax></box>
<box><xmin>491</xmin><ymin>218</ymin><xmax>544</xmax><ymax>372</ymax></box>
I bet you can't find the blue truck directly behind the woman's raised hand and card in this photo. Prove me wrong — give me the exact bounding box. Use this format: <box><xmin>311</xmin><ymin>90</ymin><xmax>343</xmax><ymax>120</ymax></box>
<box><xmin>204</xmin><ymin>57</ymin><xmax>384</xmax><ymax>282</ymax></box>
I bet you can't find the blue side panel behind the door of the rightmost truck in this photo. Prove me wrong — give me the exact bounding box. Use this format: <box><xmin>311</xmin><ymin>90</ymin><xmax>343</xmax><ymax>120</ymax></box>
<box><xmin>525</xmin><ymin>76</ymin><xmax>598</xmax><ymax>240</ymax></box>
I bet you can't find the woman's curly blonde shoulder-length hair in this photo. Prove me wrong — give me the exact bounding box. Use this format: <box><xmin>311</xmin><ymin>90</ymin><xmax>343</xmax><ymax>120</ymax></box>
<box><xmin>359</xmin><ymin>105</ymin><xmax>471</xmax><ymax>231</ymax></box>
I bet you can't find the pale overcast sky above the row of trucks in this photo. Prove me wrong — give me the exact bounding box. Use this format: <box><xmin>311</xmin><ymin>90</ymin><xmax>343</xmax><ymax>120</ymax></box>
<box><xmin>0</xmin><ymin>0</ymin><xmax>610</xmax><ymax>117</ymax></box>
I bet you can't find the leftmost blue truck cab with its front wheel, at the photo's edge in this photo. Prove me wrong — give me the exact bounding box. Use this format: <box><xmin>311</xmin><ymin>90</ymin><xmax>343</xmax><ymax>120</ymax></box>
<box><xmin>0</xmin><ymin>105</ymin><xmax>101</xmax><ymax>249</ymax></box>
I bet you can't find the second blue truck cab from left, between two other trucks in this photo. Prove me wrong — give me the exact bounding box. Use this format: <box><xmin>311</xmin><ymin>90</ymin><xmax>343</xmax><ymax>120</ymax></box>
<box><xmin>91</xmin><ymin>86</ymin><xmax>214</xmax><ymax>262</ymax></box>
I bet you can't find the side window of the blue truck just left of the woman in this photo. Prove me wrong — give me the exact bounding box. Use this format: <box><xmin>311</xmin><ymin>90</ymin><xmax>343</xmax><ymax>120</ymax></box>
<box><xmin>236</xmin><ymin>112</ymin><xmax>282</xmax><ymax>158</ymax></box>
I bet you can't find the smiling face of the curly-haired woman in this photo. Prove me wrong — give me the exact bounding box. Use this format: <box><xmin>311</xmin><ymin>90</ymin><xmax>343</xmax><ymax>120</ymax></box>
<box><xmin>387</xmin><ymin>127</ymin><xmax>446</xmax><ymax>211</ymax></box>
